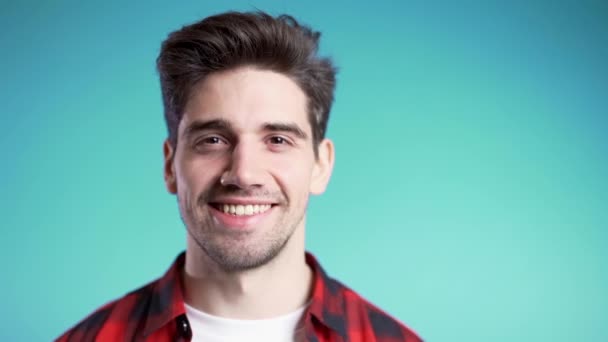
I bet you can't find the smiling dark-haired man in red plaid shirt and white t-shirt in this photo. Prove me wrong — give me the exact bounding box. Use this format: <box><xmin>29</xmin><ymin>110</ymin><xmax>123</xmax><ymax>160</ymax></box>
<box><xmin>59</xmin><ymin>12</ymin><xmax>421</xmax><ymax>342</ymax></box>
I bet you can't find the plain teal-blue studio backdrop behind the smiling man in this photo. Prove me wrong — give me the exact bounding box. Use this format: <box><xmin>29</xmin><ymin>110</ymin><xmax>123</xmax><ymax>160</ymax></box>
<box><xmin>0</xmin><ymin>0</ymin><xmax>608</xmax><ymax>342</ymax></box>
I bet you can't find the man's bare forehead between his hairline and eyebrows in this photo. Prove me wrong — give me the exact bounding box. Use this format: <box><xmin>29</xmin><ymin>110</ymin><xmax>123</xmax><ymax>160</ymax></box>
<box><xmin>180</xmin><ymin>67</ymin><xmax>311</xmax><ymax>133</ymax></box>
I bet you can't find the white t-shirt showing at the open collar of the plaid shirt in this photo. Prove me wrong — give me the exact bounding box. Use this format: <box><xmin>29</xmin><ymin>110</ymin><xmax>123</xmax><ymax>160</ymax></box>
<box><xmin>185</xmin><ymin>304</ymin><xmax>307</xmax><ymax>342</ymax></box>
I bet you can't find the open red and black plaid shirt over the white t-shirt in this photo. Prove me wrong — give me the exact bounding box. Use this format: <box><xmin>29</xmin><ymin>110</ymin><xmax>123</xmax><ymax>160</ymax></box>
<box><xmin>57</xmin><ymin>253</ymin><xmax>422</xmax><ymax>342</ymax></box>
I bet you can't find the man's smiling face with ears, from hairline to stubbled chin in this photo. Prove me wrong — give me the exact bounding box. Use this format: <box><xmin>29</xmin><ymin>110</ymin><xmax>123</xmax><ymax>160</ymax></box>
<box><xmin>165</xmin><ymin>68</ymin><xmax>333</xmax><ymax>271</ymax></box>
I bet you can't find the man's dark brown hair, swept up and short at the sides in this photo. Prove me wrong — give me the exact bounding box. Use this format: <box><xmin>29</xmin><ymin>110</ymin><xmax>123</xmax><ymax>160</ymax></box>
<box><xmin>156</xmin><ymin>12</ymin><xmax>336</xmax><ymax>154</ymax></box>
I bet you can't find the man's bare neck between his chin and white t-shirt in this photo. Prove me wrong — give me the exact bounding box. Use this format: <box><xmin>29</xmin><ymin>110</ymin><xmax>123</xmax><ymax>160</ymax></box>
<box><xmin>183</xmin><ymin>229</ymin><xmax>313</xmax><ymax>319</ymax></box>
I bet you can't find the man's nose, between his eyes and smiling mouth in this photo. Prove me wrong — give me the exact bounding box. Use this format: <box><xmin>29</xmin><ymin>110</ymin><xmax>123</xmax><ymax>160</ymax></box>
<box><xmin>220</xmin><ymin>143</ymin><xmax>264</xmax><ymax>190</ymax></box>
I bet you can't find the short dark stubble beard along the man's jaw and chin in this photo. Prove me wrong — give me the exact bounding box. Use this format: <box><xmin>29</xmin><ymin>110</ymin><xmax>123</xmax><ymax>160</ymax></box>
<box><xmin>178</xmin><ymin>188</ymin><xmax>306</xmax><ymax>273</ymax></box>
